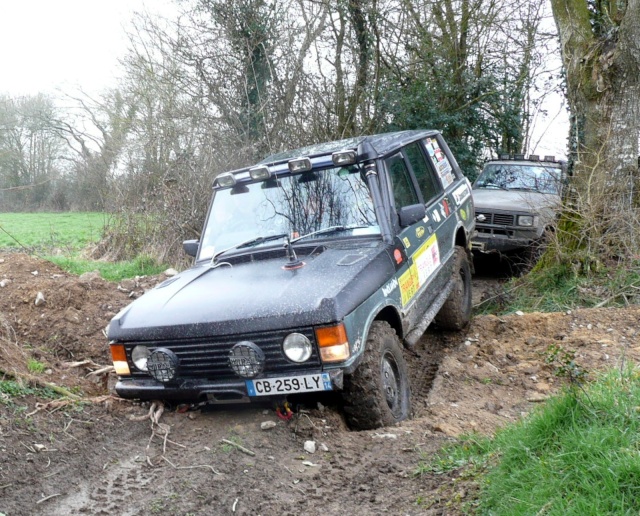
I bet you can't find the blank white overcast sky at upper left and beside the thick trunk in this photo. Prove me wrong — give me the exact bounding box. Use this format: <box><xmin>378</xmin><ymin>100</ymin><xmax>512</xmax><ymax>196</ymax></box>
<box><xmin>0</xmin><ymin>0</ymin><xmax>567</xmax><ymax>157</ymax></box>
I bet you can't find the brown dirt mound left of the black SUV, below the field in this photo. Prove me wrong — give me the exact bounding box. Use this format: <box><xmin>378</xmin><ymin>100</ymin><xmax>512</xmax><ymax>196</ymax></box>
<box><xmin>0</xmin><ymin>253</ymin><xmax>165</xmax><ymax>394</ymax></box>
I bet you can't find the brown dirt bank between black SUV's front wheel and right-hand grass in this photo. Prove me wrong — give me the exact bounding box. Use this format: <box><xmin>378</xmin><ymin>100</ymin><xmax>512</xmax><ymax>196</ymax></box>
<box><xmin>420</xmin><ymin>306</ymin><xmax>640</xmax><ymax>436</ymax></box>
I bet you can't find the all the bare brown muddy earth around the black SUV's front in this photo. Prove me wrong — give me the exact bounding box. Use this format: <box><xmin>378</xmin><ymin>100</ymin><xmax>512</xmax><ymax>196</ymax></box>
<box><xmin>0</xmin><ymin>253</ymin><xmax>640</xmax><ymax>516</ymax></box>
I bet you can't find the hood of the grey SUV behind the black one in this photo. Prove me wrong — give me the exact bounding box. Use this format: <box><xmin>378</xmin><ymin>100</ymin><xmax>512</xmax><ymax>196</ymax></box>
<box><xmin>471</xmin><ymin>188</ymin><xmax>560</xmax><ymax>213</ymax></box>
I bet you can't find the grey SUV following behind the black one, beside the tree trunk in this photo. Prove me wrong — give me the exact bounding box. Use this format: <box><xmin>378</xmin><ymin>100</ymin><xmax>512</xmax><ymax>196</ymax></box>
<box><xmin>472</xmin><ymin>155</ymin><xmax>565</xmax><ymax>253</ymax></box>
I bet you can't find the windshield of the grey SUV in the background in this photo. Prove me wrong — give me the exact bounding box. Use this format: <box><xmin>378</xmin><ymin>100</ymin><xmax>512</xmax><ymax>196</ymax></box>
<box><xmin>474</xmin><ymin>163</ymin><xmax>561</xmax><ymax>195</ymax></box>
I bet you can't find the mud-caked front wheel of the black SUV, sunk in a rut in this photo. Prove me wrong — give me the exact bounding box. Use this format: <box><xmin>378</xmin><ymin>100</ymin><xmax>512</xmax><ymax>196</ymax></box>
<box><xmin>343</xmin><ymin>321</ymin><xmax>411</xmax><ymax>430</ymax></box>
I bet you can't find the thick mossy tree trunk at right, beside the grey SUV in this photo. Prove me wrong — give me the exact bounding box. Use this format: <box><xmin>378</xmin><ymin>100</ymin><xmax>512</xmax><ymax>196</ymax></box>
<box><xmin>551</xmin><ymin>0</ymin><xmax>640</xmax><ymax>264</ymax></box>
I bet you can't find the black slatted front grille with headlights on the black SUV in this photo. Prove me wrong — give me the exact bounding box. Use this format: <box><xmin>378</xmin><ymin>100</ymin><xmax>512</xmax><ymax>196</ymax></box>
<box><xmin>125</xmin><ymin>328</ymin><xmax>320</xmax><ymax>380</ymax></box>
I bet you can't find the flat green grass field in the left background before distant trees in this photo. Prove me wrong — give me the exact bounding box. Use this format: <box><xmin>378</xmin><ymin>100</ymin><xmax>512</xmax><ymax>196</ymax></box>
<box><xmin>0</xmin><ymin>212</ymin><xmax>108</xmax><ymax>250</ymax></box>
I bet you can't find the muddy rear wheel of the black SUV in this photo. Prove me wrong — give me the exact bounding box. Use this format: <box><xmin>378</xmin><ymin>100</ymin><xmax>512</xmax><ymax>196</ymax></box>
<box><xmin>435</xmin><ymin>246</ymin><xmax>471</xmax><ymax>330</ymax></box>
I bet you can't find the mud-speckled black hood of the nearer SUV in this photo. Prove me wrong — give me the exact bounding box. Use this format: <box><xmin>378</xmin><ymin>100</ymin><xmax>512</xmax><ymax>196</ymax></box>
<box><xmin>108</xmin><ymin>242</ymin><xmax>394</xmax><ymax>341</ymax></box>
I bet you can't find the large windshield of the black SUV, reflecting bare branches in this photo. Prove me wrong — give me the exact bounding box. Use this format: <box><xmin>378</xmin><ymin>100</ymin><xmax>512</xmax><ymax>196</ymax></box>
<box><xmin>199</xmin><ymin>167</ymin><xmax>380</xmax><ymax>259</ymax></box>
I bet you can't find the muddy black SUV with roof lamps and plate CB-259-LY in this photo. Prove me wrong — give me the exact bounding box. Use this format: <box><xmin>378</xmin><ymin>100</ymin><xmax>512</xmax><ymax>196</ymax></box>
<box><xmin>108</xmin><ymin>131</ymin><xmax>474</xmax><ymax>429</ymax></box>
